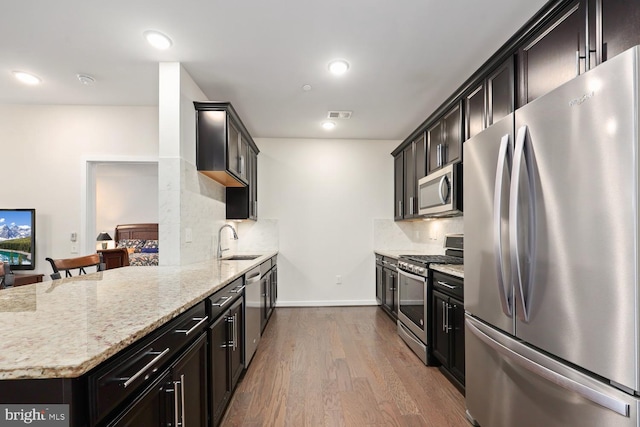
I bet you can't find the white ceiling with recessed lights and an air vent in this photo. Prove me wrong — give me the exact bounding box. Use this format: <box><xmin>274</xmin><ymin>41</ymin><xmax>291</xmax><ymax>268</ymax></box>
<box><xmin>0</xmin><ymin>0</ymin><xmax>546</xmax><ymax>139</ymax></box>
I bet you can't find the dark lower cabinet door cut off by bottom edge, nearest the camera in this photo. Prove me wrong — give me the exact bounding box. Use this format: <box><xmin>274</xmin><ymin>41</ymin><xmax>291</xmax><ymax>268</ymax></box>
<box><xmin>108</xmin><ymin>372</ymin><xmax>175</xmax><ymax>427</ymax></box>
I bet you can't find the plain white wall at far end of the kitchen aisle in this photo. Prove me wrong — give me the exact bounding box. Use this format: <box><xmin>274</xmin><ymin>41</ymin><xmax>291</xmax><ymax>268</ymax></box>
<box><xmin>256</xmin><ymin>138</ymin><xmax>399</xmax><ymax>306</ymax></box>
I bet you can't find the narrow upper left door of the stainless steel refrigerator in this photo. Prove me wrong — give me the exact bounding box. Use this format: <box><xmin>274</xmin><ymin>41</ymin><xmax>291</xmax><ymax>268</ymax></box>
<box><xmin>463</xmin><ymin>114</ymin><xmax>514</xmax><ymax>334</ymax></box>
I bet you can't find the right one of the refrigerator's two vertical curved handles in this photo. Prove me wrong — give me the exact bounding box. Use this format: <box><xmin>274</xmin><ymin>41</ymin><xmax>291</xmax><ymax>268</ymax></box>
<box><xmin>509</xmin><ymin>125</ymin><xmax>535</xmax><ymax>322</ymax></box>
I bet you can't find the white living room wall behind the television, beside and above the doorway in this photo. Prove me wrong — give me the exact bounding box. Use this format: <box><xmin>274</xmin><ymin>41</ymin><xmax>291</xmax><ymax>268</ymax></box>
<box><xmin>0</xmin><ymin>105</ymin><xmax>158</xmax><ymax>277</ymax></box>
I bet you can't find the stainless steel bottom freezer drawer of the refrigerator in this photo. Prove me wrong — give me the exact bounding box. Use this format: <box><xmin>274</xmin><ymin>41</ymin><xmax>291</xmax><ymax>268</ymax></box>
<box><xmin>465</xmin><ymin>315</ymin><xmax>640</xmax><ymax>427</ymax></box>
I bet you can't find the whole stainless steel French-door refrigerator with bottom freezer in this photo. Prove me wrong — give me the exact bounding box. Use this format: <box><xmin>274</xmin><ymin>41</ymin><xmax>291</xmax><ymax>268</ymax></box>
<box><xmin>464</xmin><ymin>47</ymin><xmax>640</xmax><ymax>427</ymax></box>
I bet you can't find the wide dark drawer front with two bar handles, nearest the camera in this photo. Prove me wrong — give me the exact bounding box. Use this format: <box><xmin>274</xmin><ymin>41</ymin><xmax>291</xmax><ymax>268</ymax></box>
<box><xmin>89</xmin><ymin>302</ymin><xmax>208</xmax><ymax>423</ymax></box>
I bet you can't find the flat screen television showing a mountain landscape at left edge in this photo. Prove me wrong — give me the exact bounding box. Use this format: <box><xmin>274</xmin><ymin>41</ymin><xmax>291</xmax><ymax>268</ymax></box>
<box><xmin>0</xmin><ymin>209</ymin><xmax>36</xmax><ymax>270</ymax></box>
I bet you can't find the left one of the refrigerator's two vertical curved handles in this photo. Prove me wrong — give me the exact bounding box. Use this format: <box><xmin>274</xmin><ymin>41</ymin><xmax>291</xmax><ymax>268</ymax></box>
<box><xmin>493</xmin><ymin>134</ymin><xmax>513</xmax><ymax>317</ymax></box>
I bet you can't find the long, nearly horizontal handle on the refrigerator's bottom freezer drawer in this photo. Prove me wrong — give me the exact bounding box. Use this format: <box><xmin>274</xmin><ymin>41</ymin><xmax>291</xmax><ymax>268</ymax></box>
<box><xmin>465</xmin><ymin>317</ymin><xmax>629</xmax><ymax>417</ymax></box>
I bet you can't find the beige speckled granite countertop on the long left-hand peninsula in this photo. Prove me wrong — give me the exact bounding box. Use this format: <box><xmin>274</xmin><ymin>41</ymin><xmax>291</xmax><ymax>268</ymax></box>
<box><xmin>0</xmin><ymin>251</ymin><xmax>277</xmax><ymax>380</ymax></box>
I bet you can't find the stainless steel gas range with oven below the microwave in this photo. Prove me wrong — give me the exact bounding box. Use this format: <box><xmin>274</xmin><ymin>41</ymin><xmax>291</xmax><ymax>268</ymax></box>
<box><xmin>398</xmin><ymin>234</ymin><xmax>464</xmax><ymax>365</ymax></box>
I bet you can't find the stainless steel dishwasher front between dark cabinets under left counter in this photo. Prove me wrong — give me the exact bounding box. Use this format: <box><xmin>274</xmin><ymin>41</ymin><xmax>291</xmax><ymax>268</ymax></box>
<box><xmin>244</xmin><ymin>266</ymin><xmax>262</xmax><ymax>369</ymax></box>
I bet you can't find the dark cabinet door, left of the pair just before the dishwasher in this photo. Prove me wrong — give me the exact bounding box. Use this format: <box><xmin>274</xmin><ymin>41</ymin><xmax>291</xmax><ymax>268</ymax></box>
<box><xmin>209</xmin><ymin>315</ymin><xmax>231</xmax><ymax>425</ymax></box>
